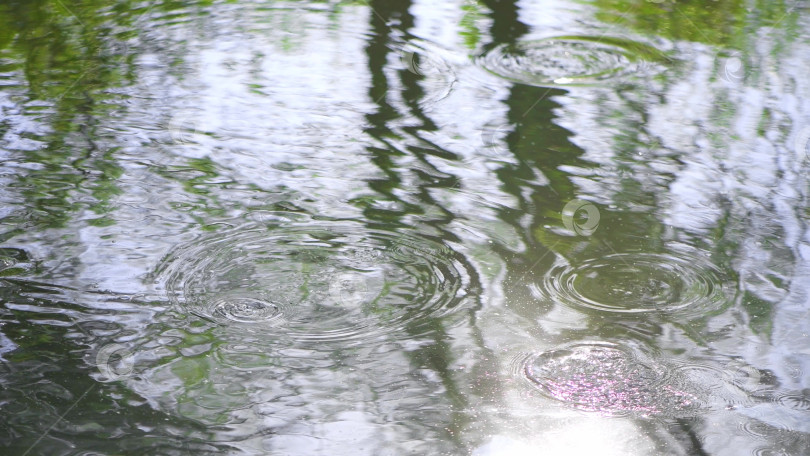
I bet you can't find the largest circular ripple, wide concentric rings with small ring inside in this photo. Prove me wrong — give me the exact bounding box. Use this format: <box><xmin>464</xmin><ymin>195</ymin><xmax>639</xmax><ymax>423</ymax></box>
<box><xmin>153</xmin><ymin>221</ymin><xmax>468</xmax><ymax>340</ymax></box>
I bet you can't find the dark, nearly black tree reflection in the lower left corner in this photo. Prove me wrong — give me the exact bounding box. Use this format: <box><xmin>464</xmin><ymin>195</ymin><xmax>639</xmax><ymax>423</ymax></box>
<box><xmin>0</xmin><ymin>280</ymin><xmax>224</xmax><ymax>455</ymax></box>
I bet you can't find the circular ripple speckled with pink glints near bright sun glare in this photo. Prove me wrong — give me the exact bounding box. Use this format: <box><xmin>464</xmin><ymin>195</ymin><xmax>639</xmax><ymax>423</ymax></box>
<box><xmin>521</xmin><ymin>343</ymin><xmax>697</xmax><ymax>416</ymax></box>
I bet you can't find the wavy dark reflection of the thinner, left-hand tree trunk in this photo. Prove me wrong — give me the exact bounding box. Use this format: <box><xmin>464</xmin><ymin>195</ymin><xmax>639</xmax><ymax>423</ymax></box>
<box><xmin>364</xmin><ymin>0</ymin><xmax>474</xmax><ymax>453</ymax></box>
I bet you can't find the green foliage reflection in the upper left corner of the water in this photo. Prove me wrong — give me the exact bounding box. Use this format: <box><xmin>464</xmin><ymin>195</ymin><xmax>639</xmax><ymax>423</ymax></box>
<box><xmin>0</xmin><ymin>0</ymin><xmax>197</xmax><ymax>227</ymax></box>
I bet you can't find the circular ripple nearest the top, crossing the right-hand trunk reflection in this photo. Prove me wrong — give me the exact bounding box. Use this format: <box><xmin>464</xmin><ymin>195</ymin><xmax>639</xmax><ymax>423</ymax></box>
<box><xmin>480</xmin><ymin>36</ymin><xmax>668</xmax><ymax>86</ymax></box>
